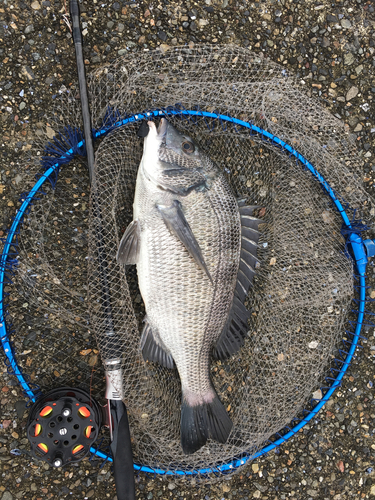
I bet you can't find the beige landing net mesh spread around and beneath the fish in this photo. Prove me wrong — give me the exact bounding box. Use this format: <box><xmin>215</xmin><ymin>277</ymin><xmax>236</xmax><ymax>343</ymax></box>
<box><xmin>8</xmin><ymin>46</ymin><xmax>374</xmax><ymax>473</ymax></box>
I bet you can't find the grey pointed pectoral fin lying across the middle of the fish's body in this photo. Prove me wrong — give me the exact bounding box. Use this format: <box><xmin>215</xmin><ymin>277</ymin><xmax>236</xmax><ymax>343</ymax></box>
<box><xmin>156</xmin><ymin>200</ymin><xmax>212</xmax><ymax>283</ymax></box>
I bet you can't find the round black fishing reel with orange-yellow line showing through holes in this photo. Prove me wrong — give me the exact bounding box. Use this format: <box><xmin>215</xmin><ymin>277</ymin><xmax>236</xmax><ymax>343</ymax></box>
<box><xmin>27</xmin><ymin>387</ymin><xmax>103</xmax><ymax>467</ymax></box>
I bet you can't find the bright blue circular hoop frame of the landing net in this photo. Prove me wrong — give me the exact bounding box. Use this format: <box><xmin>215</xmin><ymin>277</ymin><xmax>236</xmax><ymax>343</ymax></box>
<box><xmin>0</xmin><ymin>105</ymin><xmax>375</xmax><ymax>476</ymax></box>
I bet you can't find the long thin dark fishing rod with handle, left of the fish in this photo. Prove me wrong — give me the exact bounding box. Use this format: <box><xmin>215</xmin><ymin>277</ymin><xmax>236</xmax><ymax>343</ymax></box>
<box><xmin>70</xmin><ymin>0</ymin><xmax>135</xmax><ymax>500</ymax></box>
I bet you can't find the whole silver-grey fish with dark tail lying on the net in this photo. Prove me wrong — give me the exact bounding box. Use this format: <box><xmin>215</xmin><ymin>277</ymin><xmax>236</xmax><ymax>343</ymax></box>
<box><xmin>116</xmin><ymin>118</ymin><xmax>260</xmax><ymax>454</ymax></box>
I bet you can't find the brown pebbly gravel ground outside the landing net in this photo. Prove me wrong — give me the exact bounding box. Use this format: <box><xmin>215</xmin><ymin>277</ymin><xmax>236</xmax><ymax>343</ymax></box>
<box><xmin>0</xmin><ymin>0</ymin><xmax>375</xmax><ymax>500</ymax></box>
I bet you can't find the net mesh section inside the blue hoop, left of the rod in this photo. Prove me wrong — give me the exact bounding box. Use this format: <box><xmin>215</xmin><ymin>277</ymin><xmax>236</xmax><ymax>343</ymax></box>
<box><xmin>5</xmin><ymin>162</ymin><xmax>104</xmax><ymax>394</ymax></box>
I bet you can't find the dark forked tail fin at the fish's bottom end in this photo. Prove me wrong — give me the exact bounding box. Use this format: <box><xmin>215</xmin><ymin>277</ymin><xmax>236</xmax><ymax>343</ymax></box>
<box><xmin>181</xmin><ymin>389</ymin><xmax>233</xmax><ymax>455</ymax></box>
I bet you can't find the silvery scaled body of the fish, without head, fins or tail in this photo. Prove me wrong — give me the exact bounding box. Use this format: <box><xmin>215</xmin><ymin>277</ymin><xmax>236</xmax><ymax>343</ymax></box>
<box><xmin>135</xmin><ymin>165</ymin><xmax>241</xmax><ymax>396</ymax></box>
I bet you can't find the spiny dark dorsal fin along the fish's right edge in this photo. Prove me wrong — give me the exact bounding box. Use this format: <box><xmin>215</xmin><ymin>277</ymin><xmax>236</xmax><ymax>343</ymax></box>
<box><xmin>213</xmin><ymin>200</ymin><xmax>262</xmax><ymax>360</ymax></box>
